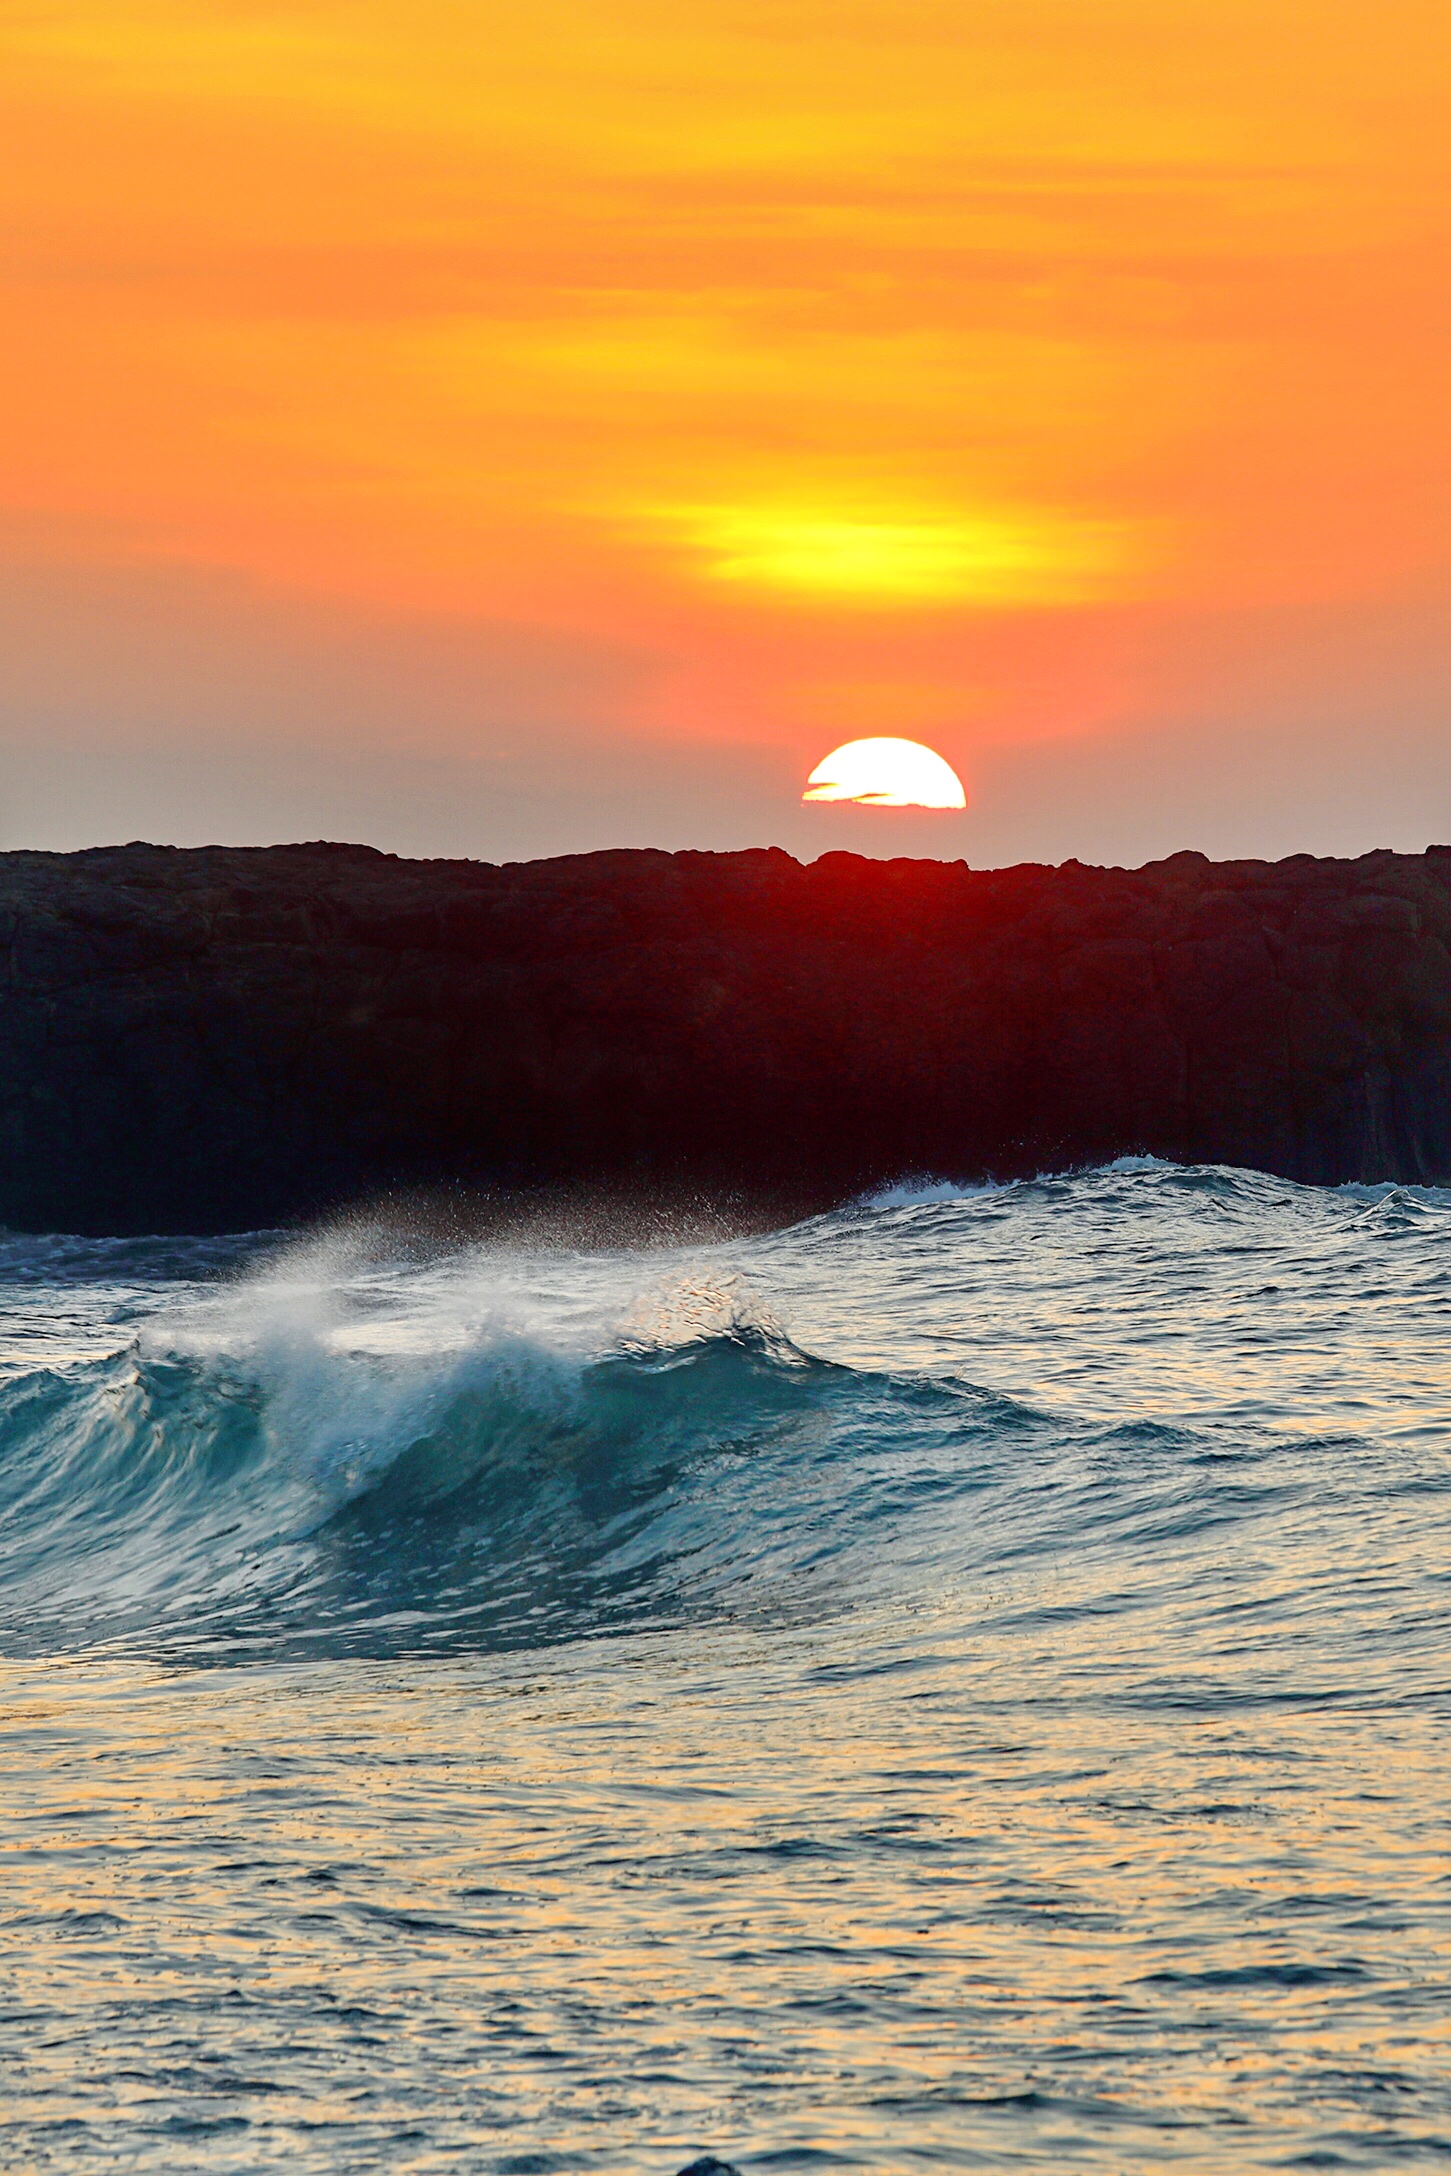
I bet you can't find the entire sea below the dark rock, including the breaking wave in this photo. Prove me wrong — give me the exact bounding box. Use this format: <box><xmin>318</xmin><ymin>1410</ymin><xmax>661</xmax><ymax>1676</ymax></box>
<box><xmin>0</xmin><ymin>1164</ymin><xmax>1451</xmax><ymax>2176</ymax></box>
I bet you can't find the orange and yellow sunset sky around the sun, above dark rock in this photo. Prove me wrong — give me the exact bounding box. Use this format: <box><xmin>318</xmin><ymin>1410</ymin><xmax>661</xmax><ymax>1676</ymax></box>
<box><xmin>0</xmin><ymin>0</ymin><xmax>1451</xmax><ymax>864</ymax></box>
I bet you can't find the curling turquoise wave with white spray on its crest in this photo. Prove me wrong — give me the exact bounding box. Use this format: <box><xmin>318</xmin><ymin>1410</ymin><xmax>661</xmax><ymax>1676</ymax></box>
<box><xmin>0</xmin><ymin>1330</ymin><xmax>1040</xmax><ymax>1656</ymax></box>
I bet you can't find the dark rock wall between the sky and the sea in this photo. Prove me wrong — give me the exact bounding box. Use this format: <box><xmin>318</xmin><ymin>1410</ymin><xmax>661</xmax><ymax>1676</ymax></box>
<box><xmin>0</xmin><ymin>846</ymin><xmax>1451</xmax><ymax>1232</ymax></box>
